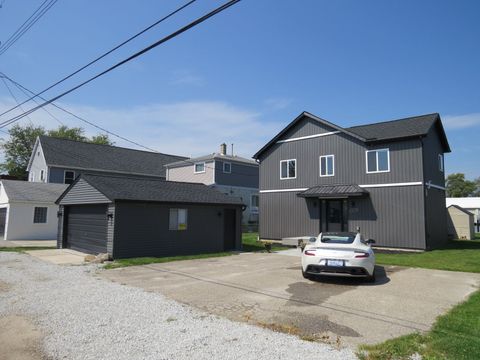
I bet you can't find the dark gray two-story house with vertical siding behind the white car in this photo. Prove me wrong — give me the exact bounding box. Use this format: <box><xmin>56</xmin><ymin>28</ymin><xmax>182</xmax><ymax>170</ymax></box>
<box><xmin>254</xmin><ymin>112</ymin><xmax>450</xmax><ymax>249</ymax></box>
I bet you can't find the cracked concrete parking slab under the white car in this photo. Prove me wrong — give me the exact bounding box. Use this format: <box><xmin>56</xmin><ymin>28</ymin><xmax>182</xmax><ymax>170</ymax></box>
<box><xmin>101</xmin><ymin>254</ymin><xmax>480</xmax><ymax>347</ymax></box>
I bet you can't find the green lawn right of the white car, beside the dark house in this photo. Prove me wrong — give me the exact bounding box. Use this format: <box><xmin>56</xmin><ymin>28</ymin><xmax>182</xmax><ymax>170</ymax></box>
<box><xmin>375</xmin><ymin>240</ymin><xmax>480</xmax><ymax>273</ymax></box>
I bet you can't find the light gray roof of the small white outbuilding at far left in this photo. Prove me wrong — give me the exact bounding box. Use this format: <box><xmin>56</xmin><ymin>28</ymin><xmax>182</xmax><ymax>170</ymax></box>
<box><xmin>1</xmin><ymin>180</ymin><xmax>68</xmax><ymax>204</ymax></box>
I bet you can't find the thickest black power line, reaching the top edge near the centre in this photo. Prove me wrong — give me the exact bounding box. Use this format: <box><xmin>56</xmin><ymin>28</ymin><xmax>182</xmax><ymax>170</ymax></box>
<box><xmin>0</xmin><ymin>0</ymin><xmax>240</xmax><ymax>128</ymax></box>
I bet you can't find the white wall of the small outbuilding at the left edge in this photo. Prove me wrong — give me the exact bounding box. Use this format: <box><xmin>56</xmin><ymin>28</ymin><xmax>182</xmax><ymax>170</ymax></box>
<box><xmin>5</xmin><ymin>203</ymin><xmax>58</xmax><ymax>240</ymax></box>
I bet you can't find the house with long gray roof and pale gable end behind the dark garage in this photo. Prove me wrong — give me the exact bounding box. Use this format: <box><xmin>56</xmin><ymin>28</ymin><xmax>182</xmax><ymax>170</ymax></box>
<box><xmin>27</xmin><ymin>136</ymin><xmax>186</xmax><ymax>184</ymax></box>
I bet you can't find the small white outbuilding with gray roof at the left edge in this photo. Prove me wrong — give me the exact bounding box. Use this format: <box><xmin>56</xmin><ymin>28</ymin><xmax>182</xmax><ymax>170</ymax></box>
<box><xmin>0</xmin><ymin>180</ymin><xmax>68</xmax><ymax>240</ymax></box>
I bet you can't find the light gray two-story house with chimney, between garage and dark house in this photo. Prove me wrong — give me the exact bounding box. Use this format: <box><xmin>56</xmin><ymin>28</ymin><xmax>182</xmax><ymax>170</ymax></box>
<box><xmin>165</xmin><ymin>144</ymin><xmax>259</xmax><ymax>225</ymax></box>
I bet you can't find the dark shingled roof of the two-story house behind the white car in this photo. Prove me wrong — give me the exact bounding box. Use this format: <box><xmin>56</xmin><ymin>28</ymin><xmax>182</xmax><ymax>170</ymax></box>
<box><xmin>253</xmin><ymin>111</ymin><xmax>450</xmax><ymax>159</ymax></box>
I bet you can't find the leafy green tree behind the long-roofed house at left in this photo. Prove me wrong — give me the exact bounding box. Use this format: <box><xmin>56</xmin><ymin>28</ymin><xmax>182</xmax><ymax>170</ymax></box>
<box><xmin>0</xmin><ymin>125</ymin><xmax>113</xmax><ymax>179</ymax></box>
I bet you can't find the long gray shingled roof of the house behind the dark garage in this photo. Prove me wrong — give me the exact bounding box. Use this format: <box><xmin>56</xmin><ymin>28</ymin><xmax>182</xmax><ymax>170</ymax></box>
<box><xmin>29</xmin><ymin>136</ymin><xmax>186</xmax><ymax>177</ymax></box>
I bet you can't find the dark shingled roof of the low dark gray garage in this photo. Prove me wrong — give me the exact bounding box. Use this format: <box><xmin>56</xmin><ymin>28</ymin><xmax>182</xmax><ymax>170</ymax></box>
<box><xmin>56</xmin><ymin>174</ymin><xmax>243</xmax><ymax>205</ymax></box>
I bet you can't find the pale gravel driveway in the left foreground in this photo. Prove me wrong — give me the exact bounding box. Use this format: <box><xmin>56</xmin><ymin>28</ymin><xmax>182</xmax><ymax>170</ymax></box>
<box><xmin>0</xmin><ymin>253</ymin><xmax>356</xmax><ymax>360</ymax></box>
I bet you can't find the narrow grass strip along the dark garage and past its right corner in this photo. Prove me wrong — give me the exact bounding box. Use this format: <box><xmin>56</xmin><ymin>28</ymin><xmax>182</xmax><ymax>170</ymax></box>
<box><xmin>105</xmin><ymin>233</ymin><xmax>286</xmax><ymax>269</ymax></box>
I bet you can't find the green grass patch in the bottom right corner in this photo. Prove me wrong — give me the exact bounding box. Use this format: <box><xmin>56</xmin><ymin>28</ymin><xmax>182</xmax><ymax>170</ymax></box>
<box><xmin>358</xmin><ymin>291</ymin><xmax>480</xmax><ymax>360</ymax></box>
